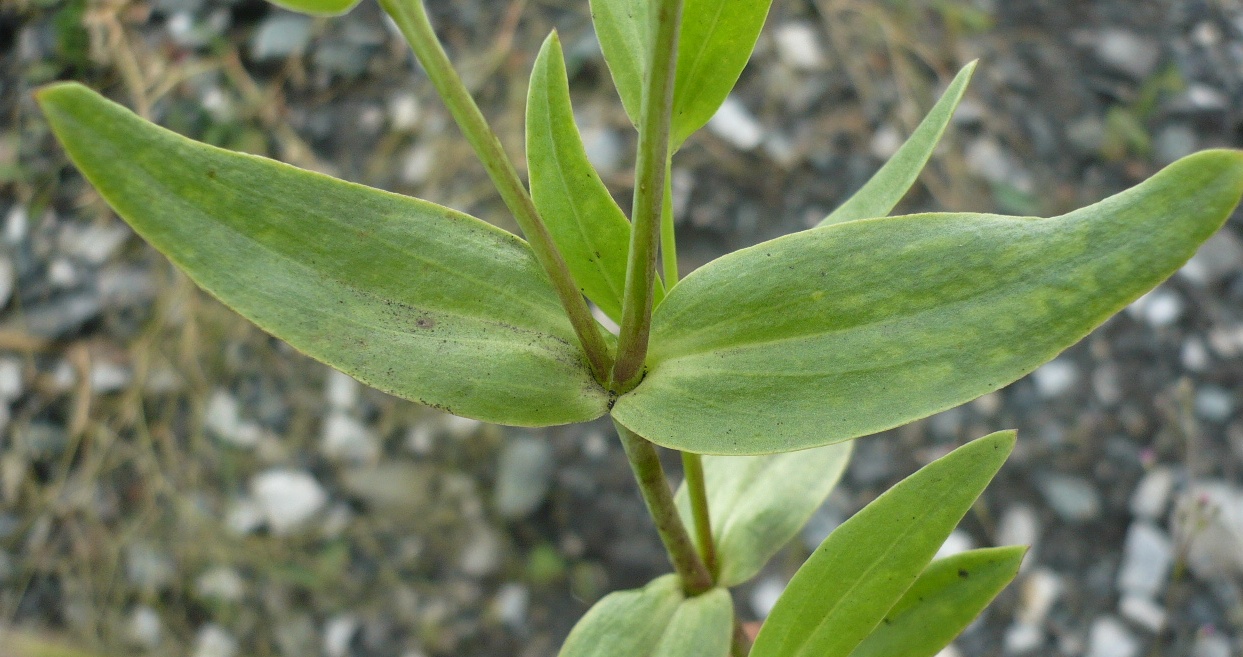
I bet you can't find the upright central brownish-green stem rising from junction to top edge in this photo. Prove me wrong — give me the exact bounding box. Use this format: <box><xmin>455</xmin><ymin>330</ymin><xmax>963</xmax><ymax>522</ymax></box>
<box><xmin>613</xmin><ymin>0</ymin><xmax>682</xmax><ymax>392</ymax></box>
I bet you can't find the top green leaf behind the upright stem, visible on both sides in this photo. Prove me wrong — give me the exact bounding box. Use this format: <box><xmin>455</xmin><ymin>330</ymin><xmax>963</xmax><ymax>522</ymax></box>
<box><xmin>592</xmin><ymin>0</ymin><xmax>772</xmax><ymax>150</ymax></box>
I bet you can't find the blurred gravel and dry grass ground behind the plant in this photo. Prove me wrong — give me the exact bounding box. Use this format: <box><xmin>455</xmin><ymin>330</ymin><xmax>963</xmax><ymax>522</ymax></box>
<box><xmin>0</xmin><ymin>0</ymin><xmax>1243</xmax><ymax>657</ymax></box>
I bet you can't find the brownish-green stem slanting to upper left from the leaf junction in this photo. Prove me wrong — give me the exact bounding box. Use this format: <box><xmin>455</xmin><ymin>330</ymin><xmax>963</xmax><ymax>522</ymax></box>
<box><xmin>379</xmin><ymin>0</ymin><xmax>611</xmax><ymax>383</ymax></box>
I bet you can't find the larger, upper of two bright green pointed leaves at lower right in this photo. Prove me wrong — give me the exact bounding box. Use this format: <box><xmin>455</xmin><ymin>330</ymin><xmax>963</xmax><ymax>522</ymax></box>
<box><xmin>751</xmin><ymin>431</ymin><xmax>1014</xmax><ymax>657</ymax></box>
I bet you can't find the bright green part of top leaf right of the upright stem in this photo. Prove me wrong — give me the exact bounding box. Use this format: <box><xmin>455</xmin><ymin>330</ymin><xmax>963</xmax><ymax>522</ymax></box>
<box><xmin>670</xmin><ymin>0</ymin><xmax>772</xmax><ymax>145</ymax></box>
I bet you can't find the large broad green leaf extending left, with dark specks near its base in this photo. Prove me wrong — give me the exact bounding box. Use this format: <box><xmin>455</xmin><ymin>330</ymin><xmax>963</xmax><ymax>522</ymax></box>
<box><xmin>39</xmin><ymin>84</ymin><xmax>608</xmax><ymax>425</ymax></box>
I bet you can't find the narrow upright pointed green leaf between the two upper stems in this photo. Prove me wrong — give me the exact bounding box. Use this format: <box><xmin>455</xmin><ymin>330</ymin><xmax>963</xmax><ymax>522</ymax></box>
<box><xmin>527</xmin><ymin>32</ymin><xmax>664</xmax><ymax>322</ymax></box>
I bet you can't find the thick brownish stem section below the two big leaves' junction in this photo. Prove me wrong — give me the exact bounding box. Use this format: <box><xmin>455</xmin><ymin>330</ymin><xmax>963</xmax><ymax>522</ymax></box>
<box><xmin>613</xmin><ymin>422</ymin><xmax>712</xmax><ymax>595</ymax></box>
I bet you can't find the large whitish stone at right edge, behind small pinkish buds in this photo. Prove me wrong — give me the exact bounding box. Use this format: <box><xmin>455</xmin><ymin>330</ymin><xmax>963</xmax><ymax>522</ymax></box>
<box><xmin>1173</xmin><ymin>479</ymin><xmax>1243</xmax><ymax>581</ymax></box>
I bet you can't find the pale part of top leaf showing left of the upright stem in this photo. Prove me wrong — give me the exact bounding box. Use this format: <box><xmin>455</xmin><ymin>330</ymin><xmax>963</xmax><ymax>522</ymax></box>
<box><xmin>590</xmin><ymin>0</ymin><xmax>651</xmax><ymax>124</ymax></box>
